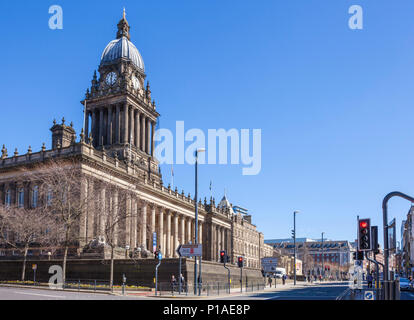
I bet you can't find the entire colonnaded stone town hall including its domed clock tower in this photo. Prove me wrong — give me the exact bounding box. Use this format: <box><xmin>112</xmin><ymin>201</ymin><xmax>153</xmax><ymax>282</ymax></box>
<box><xmin>0</xmin><ymin>15</ymin><xmax>273</xmax><ymax>276</ymax></box>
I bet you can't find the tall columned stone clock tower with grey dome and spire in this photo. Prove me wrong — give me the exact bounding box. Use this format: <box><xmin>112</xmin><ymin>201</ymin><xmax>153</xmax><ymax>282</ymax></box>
<box><xmin>82</xmin><ymin>9</ymin><xmax>160</xmax><ymax>180</ymax></box>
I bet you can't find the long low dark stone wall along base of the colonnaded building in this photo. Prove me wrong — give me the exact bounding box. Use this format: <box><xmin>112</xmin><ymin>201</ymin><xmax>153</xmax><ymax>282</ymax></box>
<box><xmin>0</xmin><ymin>259</ymin><xmax>263</xmax><ymax>287</ymax></box>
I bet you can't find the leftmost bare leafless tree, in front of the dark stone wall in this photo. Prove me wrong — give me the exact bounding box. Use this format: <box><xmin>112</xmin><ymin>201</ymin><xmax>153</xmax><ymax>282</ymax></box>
<box><xmin>0</xmin><ymin>207</ymin><xmax>56</xmax><ymax>281</ymax></box>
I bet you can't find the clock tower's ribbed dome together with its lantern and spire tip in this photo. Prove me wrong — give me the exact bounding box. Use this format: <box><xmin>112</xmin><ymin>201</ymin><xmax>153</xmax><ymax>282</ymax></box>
<box><xmin>101</xmin><ymin>9</ymin><xmax>145</xmax><ymax>72</ymax></box>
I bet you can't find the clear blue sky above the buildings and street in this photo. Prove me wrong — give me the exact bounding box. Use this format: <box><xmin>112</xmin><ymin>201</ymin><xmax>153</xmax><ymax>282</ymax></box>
<box><xmin>0</xmin><ymin>0</ymin><xmax>414</xmax><ymax>245</ymax></box>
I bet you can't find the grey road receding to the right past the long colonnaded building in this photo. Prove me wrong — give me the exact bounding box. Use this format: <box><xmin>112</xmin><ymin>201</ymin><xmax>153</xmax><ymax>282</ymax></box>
<box><xmin>217</xmin><ymin>282</ymin><xmax>348</xmax><ymax>300</ymax></box>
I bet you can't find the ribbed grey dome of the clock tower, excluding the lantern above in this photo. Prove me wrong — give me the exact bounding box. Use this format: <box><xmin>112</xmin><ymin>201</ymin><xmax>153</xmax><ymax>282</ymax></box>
<box><xmin>101</xmin><ymin>36</ymin><xmax>145</xmax><ymax>72</ymax></box>
